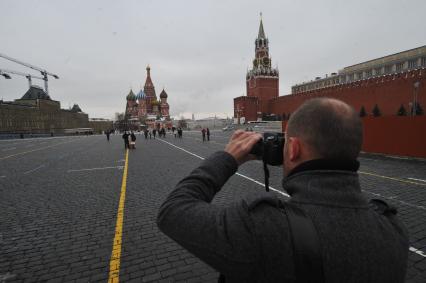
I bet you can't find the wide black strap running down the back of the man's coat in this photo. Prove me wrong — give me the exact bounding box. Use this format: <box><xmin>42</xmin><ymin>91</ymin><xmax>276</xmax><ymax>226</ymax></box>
<box><xmin>283</xmin><ymin>203</ymin><xmax>324</xmax><ymax>283</ymax></box>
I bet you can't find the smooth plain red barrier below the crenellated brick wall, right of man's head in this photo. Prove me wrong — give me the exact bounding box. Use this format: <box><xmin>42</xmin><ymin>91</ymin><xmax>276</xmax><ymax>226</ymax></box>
<box><xmin>282</xmin><ymin>115</ymin><xmax>426</xmax><ymax>158</ymax></box>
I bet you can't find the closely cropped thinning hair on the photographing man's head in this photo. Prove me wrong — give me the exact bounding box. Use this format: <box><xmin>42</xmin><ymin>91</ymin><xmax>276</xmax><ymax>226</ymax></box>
<box><xmin>287</xmin><ymin>98</ymin><xmax>362</xmax><ymax>159</ymax></box>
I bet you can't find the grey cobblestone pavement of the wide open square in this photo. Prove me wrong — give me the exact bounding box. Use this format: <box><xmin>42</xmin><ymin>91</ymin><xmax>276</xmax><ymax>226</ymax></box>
<box><xmin>0</xmin><ymin>132</ymin><xmax>426</xmax><ymax>282</ymax></box>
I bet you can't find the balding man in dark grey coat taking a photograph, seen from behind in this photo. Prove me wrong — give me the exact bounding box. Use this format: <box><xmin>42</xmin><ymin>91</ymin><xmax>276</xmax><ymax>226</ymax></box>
<box><xmin>157</xmin><ymin>98</ymin><xmax>408</xmax><ymax>282</ymax></box>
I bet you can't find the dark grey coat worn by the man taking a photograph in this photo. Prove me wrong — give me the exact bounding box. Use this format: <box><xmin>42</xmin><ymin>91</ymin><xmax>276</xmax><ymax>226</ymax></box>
<box><xmin>157</xmin><ymin>152</ymin><xmax>408</xmax><ymax>283</ymax></box>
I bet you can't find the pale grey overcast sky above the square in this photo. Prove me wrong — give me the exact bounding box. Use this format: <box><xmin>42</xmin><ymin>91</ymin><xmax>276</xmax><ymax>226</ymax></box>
<box><xmin>0</xmin><ymin>0</ymin><xmax>426</xmax><ymax>118</ymax></box>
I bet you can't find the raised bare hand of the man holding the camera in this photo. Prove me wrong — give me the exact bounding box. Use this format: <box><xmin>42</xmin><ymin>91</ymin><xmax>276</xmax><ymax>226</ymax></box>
<box><xmin>225</xmin><ymin>130</ymin><xmax>262</xmax><ymax>165</ymax></box>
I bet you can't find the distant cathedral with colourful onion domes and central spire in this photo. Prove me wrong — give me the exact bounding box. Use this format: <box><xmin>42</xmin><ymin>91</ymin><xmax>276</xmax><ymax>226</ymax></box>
<box><xmin>125</xmin><ymin>66</ymin><xmax>172</xmax><ymax>130</ymax></box>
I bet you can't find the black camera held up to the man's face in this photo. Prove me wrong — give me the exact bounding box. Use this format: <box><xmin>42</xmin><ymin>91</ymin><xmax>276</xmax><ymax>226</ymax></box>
<box><xmin>250</xmin><ymin>133</ymin><xmax>285</xmax><ymax>166</ymax></box>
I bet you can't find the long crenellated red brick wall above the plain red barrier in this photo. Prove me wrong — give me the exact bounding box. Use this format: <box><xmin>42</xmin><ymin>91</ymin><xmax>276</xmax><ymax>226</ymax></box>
<box><xmin>267</xmin><ymin>69</ymin><xmax>426</xmax><ymax>116</ymax></box>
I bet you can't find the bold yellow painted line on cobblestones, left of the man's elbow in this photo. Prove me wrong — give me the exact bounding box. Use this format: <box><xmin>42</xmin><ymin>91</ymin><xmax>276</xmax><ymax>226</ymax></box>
<box><xmin>108</xmin><ymin>149</ymin><xmax>129</xmax><ymax>283</ymax></box>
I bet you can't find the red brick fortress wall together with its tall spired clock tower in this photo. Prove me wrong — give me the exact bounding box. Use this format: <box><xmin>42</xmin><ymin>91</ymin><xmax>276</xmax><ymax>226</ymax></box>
<box><xmin>234</xmin><ymin>20</ymin><xmax>426</xmax><ymax>158</ymax></box>
